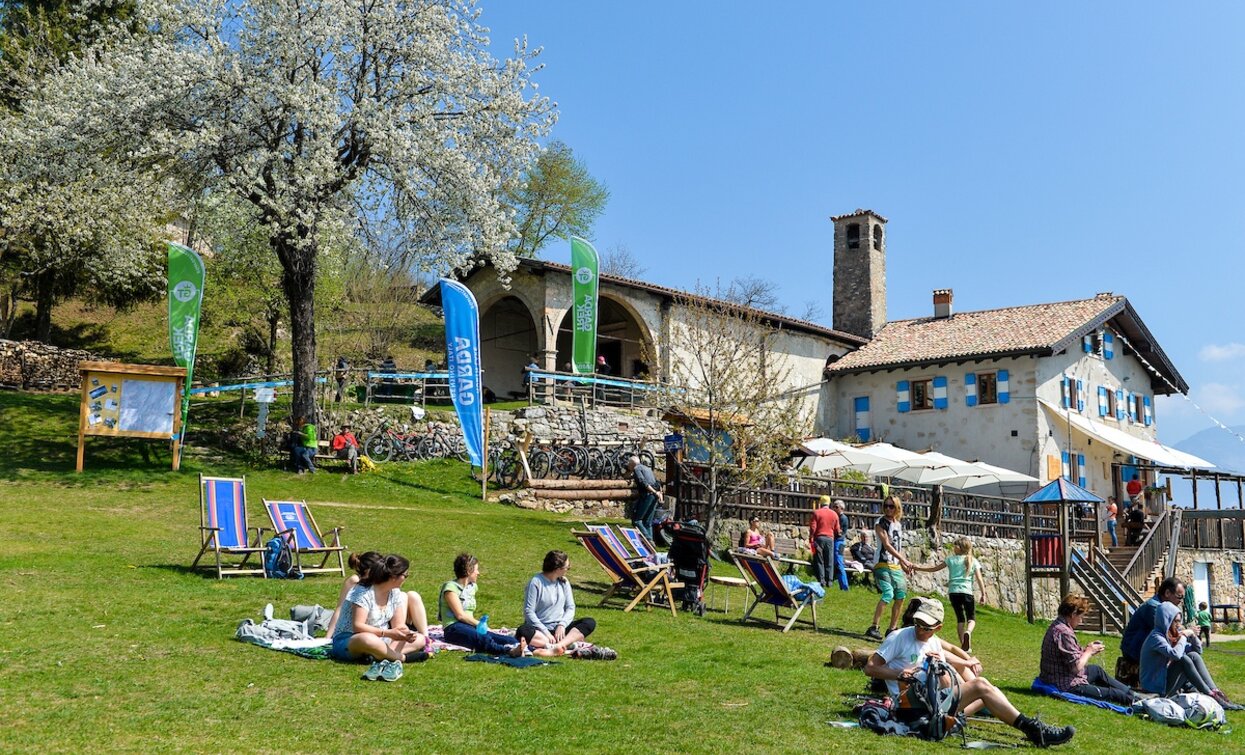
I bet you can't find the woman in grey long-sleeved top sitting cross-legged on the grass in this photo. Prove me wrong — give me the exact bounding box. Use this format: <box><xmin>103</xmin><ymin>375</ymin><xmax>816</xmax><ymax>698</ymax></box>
<box><xmin>514</xmin><ymin>551</ymin><xmax>618</xmax><ymax>660</ymax></box>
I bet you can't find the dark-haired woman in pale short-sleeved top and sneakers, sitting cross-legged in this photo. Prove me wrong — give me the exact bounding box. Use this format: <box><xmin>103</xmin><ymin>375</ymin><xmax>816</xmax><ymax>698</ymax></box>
<box><xmin>329</xmin><ymin>556</ymin><xmax>427</xmax><ymax>681</ymax></box>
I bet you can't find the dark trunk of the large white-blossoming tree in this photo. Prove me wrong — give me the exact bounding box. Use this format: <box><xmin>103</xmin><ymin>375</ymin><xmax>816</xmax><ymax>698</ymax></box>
<box><xmin>273</xmin><ymin>234</ymin><xmax>316</xmax><ymax>422</ymax></box>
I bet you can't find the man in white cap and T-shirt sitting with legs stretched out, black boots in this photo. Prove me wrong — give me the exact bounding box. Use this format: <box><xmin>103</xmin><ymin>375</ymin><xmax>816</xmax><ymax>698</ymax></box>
<box><xmin>864</xmin><ymin>598</ymin><xmax>1076</xmax><ymax>748</ymax></box>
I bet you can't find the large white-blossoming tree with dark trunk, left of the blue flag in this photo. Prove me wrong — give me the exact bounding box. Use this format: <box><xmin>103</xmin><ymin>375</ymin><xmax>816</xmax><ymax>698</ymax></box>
<box><xmin>4</xmin><ymin>0</ymin><xmax>554</xmax><ymax>416</ymax></box>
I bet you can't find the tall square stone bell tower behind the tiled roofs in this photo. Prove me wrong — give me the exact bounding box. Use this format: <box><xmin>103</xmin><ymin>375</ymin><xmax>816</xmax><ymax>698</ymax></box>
<box><xmin>830</xmin><ymin>209</ymin><xmax>886</xmax><ymax>338</ymax></box>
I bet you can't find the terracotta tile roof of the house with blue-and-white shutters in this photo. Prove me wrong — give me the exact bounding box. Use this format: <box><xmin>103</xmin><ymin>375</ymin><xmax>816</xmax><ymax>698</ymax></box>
<box><xmin>827</xmin><ymin>294</ymin><xmax>1127</xmax><ymax>373</ymax></box>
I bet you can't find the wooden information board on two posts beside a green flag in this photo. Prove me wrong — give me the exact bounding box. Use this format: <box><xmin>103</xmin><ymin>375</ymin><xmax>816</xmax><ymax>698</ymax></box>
<box><xmin>77</xmin><ymin>361</ymin><xmax>186</xmax><ymax>472</ymax></box>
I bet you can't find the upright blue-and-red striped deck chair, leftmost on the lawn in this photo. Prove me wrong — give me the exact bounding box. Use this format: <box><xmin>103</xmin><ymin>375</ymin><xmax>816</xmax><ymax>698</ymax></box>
<box><xmin>190</xmin><ymin>475</ymin><xmax>268</xmax><ymax>579</ymax></box>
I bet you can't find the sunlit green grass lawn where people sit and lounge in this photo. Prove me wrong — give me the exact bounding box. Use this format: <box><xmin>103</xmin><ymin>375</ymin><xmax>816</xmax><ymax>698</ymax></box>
<box><xmin>0</xmin><ymin>392</ymin><xmax>1245</xmax><ymax>753</ymax></box>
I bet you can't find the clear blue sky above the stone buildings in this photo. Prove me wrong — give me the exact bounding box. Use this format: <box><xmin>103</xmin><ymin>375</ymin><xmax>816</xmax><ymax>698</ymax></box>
<box><xmin>482</xmin><ymin>0</ymin><xmax>1245</xmax><ymax>442</ymax></box>
